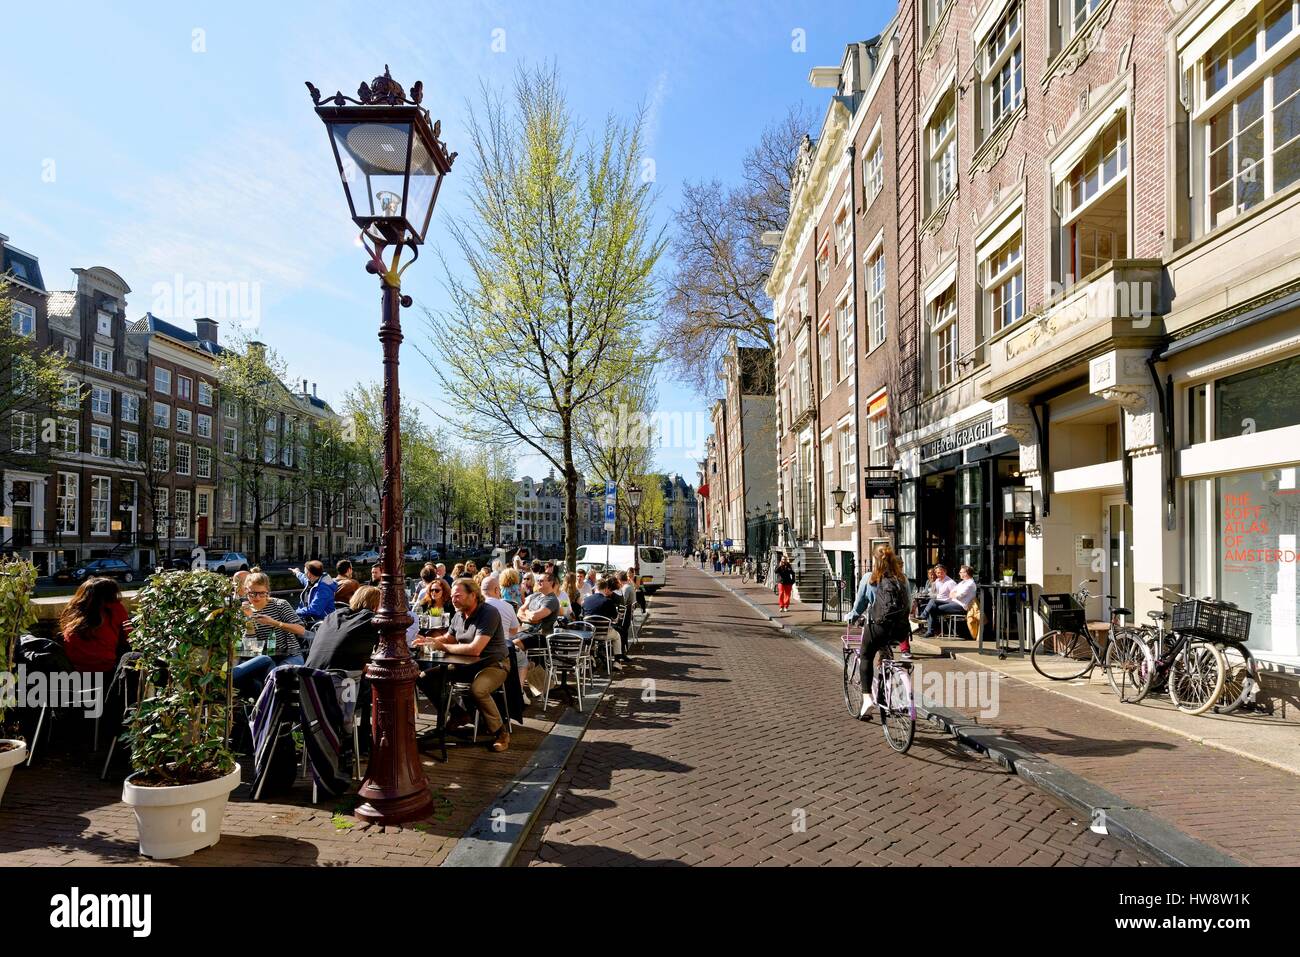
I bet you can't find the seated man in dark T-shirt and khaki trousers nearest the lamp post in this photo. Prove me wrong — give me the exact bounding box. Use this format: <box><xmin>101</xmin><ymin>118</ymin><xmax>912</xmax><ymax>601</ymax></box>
<box><xmin>419</xmin><ymin>579</ymin><xmax>510</xmax><ymax>753</ymax></box>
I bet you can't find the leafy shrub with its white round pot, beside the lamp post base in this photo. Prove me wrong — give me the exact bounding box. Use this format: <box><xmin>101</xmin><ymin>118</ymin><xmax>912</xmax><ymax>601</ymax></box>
<box><xmin>122</xmin><ymin>571</ymin><xmax>244</xmax><ymax>858</ymax></box>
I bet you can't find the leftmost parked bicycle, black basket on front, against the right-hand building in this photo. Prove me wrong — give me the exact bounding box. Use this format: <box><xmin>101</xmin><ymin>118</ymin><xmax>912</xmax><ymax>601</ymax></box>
<box><xmin>1030</xmin><ymin>579</ymin><xmax>1152</xmax><ymax>701</ymax></box>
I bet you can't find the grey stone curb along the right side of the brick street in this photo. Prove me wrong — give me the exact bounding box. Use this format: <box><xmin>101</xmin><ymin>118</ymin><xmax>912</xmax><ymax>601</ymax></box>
<box><xmin>709</xmin><ymin>576</ymin><xmax>1243</xmax><ymax>867</ymax></box>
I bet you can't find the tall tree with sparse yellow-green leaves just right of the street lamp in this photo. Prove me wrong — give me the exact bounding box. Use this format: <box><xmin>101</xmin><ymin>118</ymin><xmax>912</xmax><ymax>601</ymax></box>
<box><xmin>428</xmin><ymin>69</ymin><xmax>664</xmax><ymax>567</ymax></box>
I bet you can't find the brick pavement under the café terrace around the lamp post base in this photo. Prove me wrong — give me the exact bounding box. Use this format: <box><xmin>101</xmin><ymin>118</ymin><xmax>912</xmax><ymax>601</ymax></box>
<box><xmin>0</xmin><ymin>700</ymin><xmax>566</xmax><ymax>867</ymax></box>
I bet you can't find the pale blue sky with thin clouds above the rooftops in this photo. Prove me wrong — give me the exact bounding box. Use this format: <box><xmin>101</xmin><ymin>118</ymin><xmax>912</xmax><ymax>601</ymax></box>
<box><xmin>0</xmin><ymin>0</ymin><xmax>893</xmax><ymax>481</ymax></box>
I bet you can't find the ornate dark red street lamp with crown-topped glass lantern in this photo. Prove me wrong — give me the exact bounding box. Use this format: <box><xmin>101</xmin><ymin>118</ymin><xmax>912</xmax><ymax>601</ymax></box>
<box><xmin>307</xmin><ymin>66</ymin><xmax>456</xmax><ymax>824</ymax></box>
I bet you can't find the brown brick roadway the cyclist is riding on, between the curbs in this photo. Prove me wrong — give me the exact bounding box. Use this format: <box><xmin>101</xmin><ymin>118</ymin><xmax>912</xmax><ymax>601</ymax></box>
<box><xmin>517</xmin><ymin>563</ymin><xmax>1145</xmax><ymax>866</ymax></box>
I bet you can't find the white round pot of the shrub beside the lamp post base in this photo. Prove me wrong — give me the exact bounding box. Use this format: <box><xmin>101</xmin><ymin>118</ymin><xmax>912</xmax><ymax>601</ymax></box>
<box><xmin>122</xmin><ymin>765</ymin><xmax>239</xmax><ymax>861</ymax></box>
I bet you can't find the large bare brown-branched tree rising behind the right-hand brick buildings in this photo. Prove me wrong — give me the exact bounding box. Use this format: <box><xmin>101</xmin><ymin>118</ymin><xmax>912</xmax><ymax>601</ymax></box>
<box><xmin>663</xmin><ymin>107</ymin><xmax>813</xmax><ymax>395</ymax></box>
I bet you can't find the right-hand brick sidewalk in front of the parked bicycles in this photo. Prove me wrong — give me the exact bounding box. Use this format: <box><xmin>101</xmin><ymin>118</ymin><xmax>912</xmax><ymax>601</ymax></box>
<box><xmin>709</xmin><ymin>561</ymin><xmax>1300</xmax><ymax>865</ymax></box>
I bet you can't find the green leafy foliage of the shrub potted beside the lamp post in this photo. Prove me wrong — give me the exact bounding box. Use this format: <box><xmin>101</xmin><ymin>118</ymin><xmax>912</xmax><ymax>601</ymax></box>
<box><xmin>125</xmin><ymin>571</ymin><xmax>244</xmax><ymax>787</ymax></box>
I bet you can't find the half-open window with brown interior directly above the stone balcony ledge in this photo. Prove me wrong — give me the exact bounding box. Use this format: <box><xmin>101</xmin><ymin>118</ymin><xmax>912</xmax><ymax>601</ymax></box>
<box><xmin>1056</xmin><ymin>112</ymin><xmax>1128</xmax><ymax>287</ymax></box>
